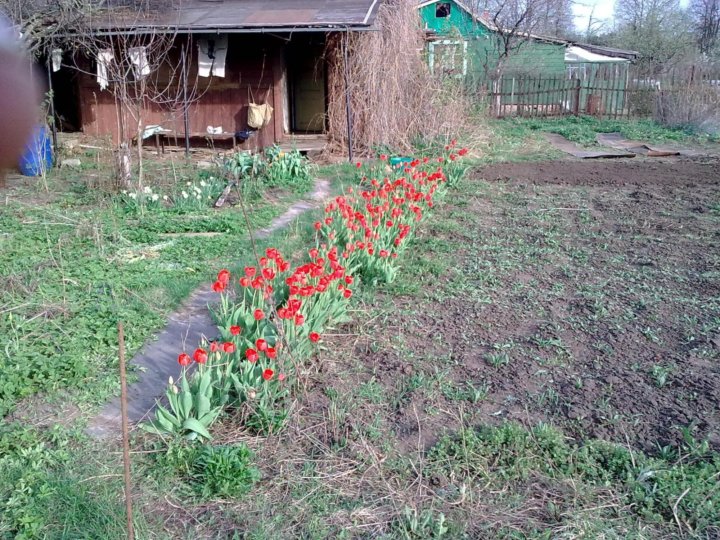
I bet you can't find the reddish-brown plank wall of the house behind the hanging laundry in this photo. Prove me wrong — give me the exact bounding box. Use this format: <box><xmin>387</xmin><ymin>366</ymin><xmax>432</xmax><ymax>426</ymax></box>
<box><xmin>79</xmin><ymin>34</ymin><xmax>283</xmax><ymax>149</ymax></box>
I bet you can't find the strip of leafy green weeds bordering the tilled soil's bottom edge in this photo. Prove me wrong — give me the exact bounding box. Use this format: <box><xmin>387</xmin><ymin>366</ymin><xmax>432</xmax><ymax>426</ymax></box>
<box><xmin>428</xmin><ymin>424</ymin><xmax>720</xmax><ymax>533</ymax></box>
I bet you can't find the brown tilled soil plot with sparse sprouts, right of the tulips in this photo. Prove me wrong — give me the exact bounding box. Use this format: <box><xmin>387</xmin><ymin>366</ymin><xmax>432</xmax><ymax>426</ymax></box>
<box><xmin>323</xmin><ymin>159</ymin><xmax>720</xmax><ymax>453</ymax></box>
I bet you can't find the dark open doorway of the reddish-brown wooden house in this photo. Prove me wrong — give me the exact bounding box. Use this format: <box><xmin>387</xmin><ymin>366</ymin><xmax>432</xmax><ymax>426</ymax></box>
<box><xmin>288</xmin><ymin>44</ymin><xmax>327</xmax><ymax>133</ymax></box>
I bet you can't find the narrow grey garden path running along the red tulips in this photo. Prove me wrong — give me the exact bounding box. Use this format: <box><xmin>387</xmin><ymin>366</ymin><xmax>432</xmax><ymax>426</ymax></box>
<box><xmin>86</xmin><ymin>179</ymin><xmax>330</xmax><ymax>437</ymax></box>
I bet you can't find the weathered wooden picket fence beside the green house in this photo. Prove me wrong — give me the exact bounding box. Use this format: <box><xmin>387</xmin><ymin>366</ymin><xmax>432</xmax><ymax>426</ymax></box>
<box><xmin>485</xmin><ymin>65</ymin><xmax>720</xmax><ymax>118</ymax></box>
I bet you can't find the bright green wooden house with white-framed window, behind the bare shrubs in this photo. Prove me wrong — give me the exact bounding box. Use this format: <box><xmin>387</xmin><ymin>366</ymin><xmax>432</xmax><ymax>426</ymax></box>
<box><xmin>418</xmin><ymin>0</ymin><xmax>638</xmax><ymax>114</ymax></box>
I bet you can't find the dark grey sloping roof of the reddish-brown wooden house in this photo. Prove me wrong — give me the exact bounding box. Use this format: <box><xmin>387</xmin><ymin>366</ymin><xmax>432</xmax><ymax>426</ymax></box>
<box><xmin>91</xmin><ymin>0</ymin><xmax>381</xmax><ymax>34</ymax></box>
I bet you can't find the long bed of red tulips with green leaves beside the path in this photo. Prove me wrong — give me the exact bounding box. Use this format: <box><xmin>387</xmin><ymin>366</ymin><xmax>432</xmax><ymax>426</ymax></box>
<box><xmin>144</xmin><ymin>141</ymin><xmax>467</xmax><ymax>439</ymax></box>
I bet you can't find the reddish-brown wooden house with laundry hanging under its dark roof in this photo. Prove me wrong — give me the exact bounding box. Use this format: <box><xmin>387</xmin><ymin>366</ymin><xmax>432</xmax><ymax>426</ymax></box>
<box><xmin>51</xmin><ymin>0</ymin><xmax>379</xmax><ymax>150</ymax></box>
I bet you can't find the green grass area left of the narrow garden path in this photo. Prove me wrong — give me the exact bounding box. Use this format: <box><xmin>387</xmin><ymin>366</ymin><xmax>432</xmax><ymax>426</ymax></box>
<box><xmin>0</xmin><ymin>157</ymin><xmax>300</xmax><ymax>415</ymax></box>
